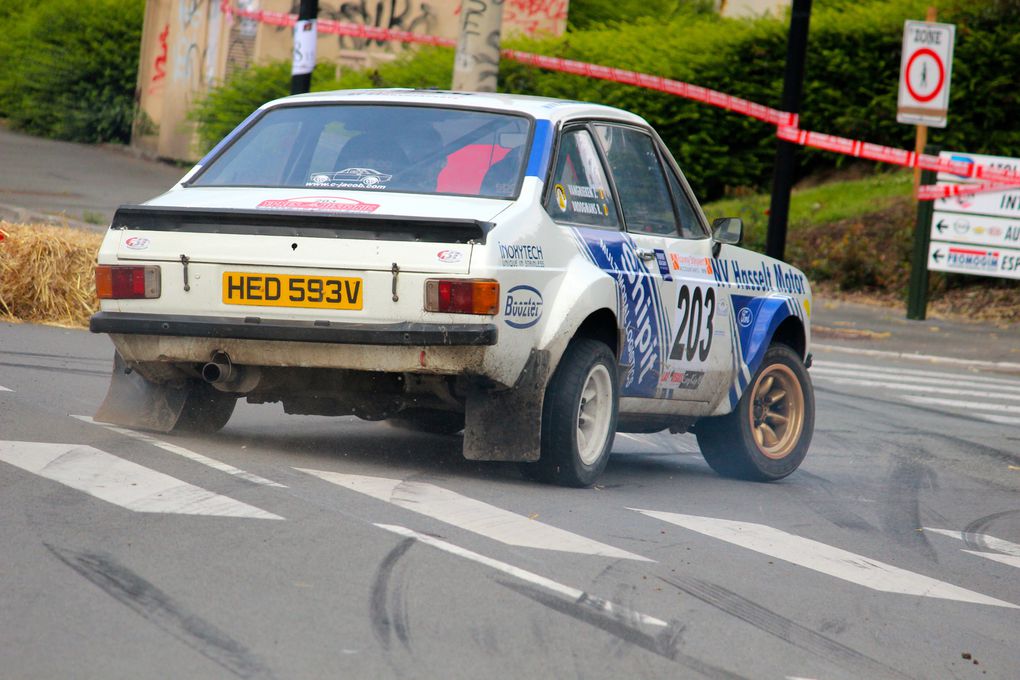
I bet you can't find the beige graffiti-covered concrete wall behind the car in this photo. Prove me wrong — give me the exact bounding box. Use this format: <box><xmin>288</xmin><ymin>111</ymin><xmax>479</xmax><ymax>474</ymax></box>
<box><xmin>132</xmin><ymin>0</ymin><xmax>569</xmax><ymax>160</ymax></box>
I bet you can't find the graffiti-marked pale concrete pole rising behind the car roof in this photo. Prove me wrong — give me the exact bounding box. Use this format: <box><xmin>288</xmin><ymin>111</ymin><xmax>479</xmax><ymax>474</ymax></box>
<box><xmin>453</xmin><ymin>0</ymin><xmax>504</xmax><ymax>92</ymax></box>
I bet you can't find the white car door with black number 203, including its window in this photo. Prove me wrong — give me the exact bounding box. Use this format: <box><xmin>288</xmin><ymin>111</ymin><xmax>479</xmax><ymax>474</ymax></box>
<box><xmin>593</xmin><ymin>122</ymin><xmax>732</xmax><ymax>403</ymax></box>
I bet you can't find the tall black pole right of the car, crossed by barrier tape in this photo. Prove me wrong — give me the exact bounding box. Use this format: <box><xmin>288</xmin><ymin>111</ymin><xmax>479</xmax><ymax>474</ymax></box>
<box><xmin>765</xmin><ymin>0</ymin><xmax>811</xmax><ymax>260</ymax></box>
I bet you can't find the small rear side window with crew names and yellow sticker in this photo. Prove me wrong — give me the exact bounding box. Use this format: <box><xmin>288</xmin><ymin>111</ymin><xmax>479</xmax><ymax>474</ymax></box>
<box><xmin>546</xmin><ymin>129</ymin><xmax>619</xmax><ymax>228</ymax></box>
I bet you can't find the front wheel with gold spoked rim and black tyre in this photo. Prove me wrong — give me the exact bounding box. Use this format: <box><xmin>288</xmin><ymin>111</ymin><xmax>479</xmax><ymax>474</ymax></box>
<box><xmin>695</xmin><ymin>344</ymin><xmax>815</xmax><ymax>481</ymax></box>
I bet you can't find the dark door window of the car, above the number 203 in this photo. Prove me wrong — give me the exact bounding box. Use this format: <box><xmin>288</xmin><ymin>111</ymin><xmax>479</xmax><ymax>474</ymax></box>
<box><xmin>595</xmin><ymin>124</ymin><xmax>679</xmax><ymax>237</ymax></box>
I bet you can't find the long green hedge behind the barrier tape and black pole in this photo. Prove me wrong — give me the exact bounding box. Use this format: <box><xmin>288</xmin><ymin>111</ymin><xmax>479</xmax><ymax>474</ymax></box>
<box><xmin>189</xmin><ymin>0</ymin><xmax>1020</xmax><ymax>200</ymax></box>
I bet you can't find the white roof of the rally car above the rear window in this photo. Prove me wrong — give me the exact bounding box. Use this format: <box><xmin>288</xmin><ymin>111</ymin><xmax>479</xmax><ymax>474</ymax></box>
<box><xmin>263</xmin><ymin>88</ymin><xmax>648</xmax><ymax>125</ymax></box>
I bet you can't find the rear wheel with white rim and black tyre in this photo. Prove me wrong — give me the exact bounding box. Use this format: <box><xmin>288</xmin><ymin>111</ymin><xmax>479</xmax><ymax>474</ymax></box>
<box><xmin>521</xmin><ymin>338</ymin><xmax>619</xmax><ymax>487</ymax></box>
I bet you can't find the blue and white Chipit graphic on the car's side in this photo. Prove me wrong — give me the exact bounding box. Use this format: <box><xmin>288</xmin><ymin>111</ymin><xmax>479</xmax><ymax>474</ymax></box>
<box><xmin>571</xmin><ymin>227</ymin><xmax>670</xmax><ymax>397</ymax></box>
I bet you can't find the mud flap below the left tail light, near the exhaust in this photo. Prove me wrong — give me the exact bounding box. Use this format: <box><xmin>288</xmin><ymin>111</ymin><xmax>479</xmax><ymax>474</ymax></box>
<box><xmin>95</xmin><ymin>352</ymin><xmax>188</xmax><ymax>432</ymax></box>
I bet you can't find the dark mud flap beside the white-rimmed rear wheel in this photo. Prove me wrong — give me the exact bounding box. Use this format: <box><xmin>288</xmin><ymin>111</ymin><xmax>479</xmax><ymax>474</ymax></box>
<box><xmin>464</xmin><ymin>350</ymin><xmax>549</xmax><ymax>463</ymax></box>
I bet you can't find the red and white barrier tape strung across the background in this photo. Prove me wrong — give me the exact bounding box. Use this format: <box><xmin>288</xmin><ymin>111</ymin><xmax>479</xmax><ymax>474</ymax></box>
<box><xmin>220</xmin><ymin>0</ymin><xmax>1020</xmax><ymax>201</ymax></box>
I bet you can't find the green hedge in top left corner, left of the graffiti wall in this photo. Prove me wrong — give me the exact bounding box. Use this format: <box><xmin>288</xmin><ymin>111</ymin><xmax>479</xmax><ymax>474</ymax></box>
<box><xmin>0</xmin><ymin>0</ymin><xmax>145</xmax><ymax>142</ymax></box>
